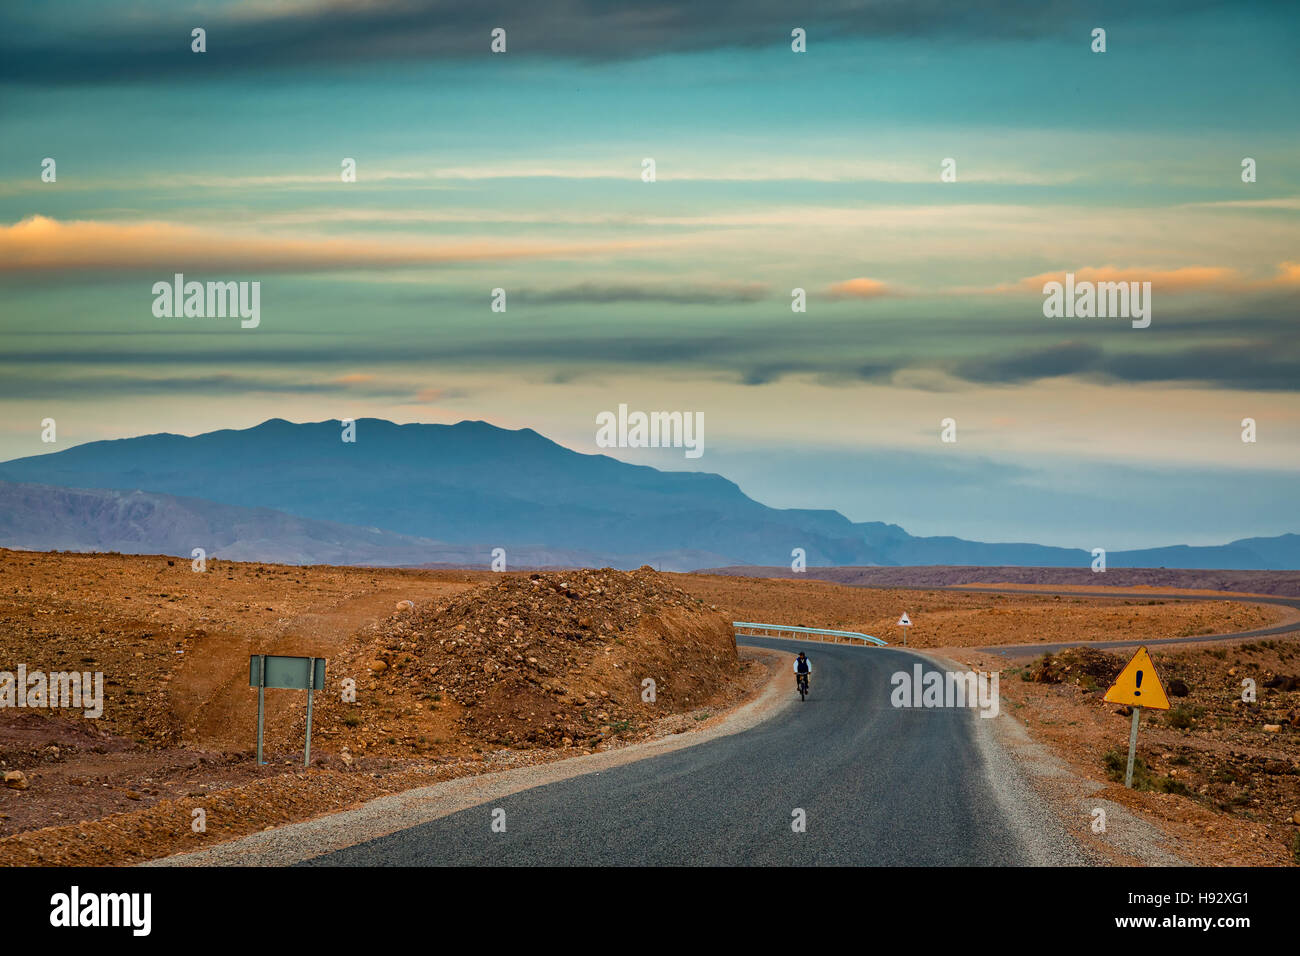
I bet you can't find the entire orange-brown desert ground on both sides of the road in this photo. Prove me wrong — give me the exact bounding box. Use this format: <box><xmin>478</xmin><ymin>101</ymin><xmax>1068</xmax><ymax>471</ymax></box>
<box><xmin>0</xmin><ymin>550</ymin><xmax>1300</xmax><ymax>865</ymax></box>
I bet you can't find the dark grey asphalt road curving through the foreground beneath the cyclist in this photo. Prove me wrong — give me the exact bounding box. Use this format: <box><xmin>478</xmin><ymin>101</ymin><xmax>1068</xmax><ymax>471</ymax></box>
<box><xmin>303</xmin><ymin>637</ymin><xmax>1083</xmax><ymax>866</ymax></box>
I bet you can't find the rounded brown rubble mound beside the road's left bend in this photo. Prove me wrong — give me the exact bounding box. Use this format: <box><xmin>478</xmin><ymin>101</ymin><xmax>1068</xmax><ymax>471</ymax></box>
<box><xmin>325</xmin><ymin>568</ymin><xmax>741</xmax><ymax>750</ymax></box>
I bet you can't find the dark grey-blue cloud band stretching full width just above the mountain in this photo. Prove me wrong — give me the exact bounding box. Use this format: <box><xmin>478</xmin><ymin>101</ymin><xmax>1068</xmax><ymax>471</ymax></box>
<box><xmin>0</xmin><ymin>319</ymin><xmax>1300</xmax><ymax>401</ymax></box>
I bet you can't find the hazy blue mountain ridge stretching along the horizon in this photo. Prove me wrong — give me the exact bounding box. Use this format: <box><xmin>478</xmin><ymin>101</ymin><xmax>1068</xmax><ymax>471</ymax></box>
<box><xmin>0</xmin><ymin>419</ymin><xmax>1300</xmax><ymax>570</ymax></box>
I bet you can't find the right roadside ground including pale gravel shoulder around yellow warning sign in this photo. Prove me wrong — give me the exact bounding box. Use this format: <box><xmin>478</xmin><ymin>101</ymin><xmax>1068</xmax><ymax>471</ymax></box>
<box><xmin>952</xmin><ymin>639</ymin><xmax>1300</xmax><ymax>866</ymax></box>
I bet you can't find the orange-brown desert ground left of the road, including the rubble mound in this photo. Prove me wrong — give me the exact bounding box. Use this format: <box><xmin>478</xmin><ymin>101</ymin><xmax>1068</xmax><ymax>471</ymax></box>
<box><xmin>0</xmin><ymin>550</ymin><xmax>753</xmax><ymax>864</ymax></box>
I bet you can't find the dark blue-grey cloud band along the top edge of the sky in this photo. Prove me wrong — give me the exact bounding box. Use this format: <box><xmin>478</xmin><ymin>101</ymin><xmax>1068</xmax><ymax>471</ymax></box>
<box><xmin>0</xmin><ymin>0</ymin><xmax>1222</xmax><ymax>85</ymax></box>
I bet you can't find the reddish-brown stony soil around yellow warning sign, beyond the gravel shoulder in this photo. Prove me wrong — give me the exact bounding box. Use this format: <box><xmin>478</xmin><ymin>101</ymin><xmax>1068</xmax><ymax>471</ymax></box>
<box><xmin>959</xmin><ymin>640</ymin><xmax>1300</xmax><ymax>866</ymax></box>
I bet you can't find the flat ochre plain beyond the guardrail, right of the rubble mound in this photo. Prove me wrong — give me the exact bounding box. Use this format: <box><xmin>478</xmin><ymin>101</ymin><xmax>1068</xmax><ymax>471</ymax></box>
<box><xmin>679</xmin><ymin>575</ymin><xmax>1296</xmax><ymax>648</ymax></box>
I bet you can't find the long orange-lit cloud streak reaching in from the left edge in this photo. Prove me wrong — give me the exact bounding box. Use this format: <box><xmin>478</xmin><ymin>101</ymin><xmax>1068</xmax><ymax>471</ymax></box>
<box><xmin>0</xmin><ymin>216</ymin><xmax>650</xmax><ymax>274</ymax></box>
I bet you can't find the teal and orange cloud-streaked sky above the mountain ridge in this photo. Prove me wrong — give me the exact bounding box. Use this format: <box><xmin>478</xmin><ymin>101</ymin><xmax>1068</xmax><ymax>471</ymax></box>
<box><xmin>0</xmin><ymin>0</ymin><xmax>1300</xmax><ymax>549</ymax></box>
